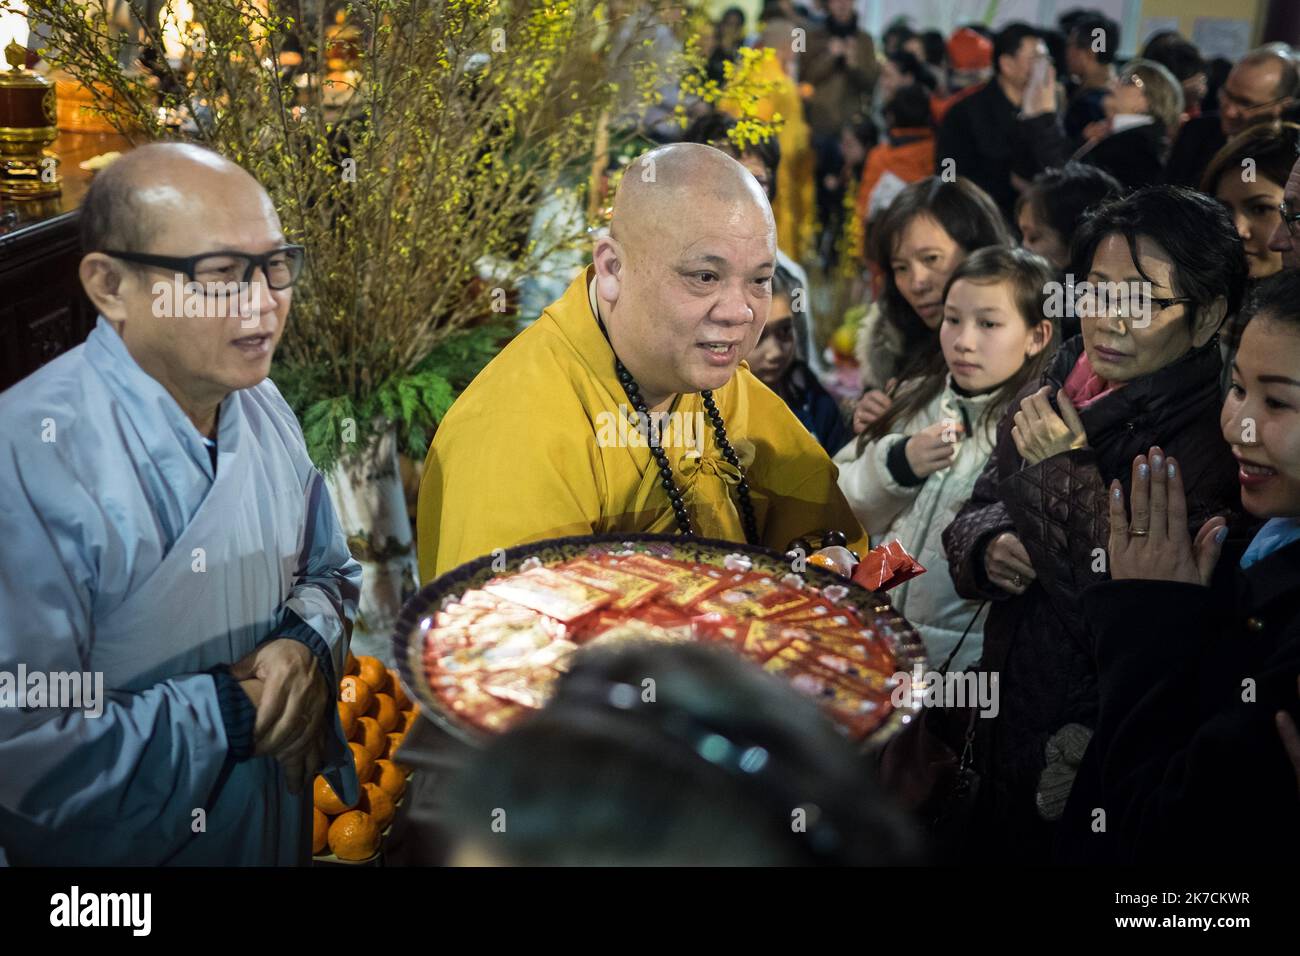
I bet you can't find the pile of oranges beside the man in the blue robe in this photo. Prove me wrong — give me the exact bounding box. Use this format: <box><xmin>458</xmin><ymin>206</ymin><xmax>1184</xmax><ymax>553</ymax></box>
<box><xmin>312</xmin><ymin>652</ymin><xmax>416</xmax><ymax>860</ymax></box>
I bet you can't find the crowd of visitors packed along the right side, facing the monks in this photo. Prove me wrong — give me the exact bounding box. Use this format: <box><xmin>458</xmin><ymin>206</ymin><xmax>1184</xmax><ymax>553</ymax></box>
<box><xmin>478</xmin><ymin>0</ymin><xmax>1300</xmax><ymax>862</ymax></box>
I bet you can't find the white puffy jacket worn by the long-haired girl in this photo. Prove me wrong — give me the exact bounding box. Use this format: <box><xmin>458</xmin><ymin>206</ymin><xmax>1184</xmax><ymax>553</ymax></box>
<box><xmin>835</xmin><ymin>376</ymin><xmax>1002</xmax><ymax>671</ymax></box>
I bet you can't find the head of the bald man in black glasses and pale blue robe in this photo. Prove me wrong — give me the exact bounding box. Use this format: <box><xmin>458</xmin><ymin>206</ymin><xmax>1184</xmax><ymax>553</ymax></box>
<box><xmin>78</xmin><ymin>143</ymin><xmax>295</xmax><ymax>416</ymax></box>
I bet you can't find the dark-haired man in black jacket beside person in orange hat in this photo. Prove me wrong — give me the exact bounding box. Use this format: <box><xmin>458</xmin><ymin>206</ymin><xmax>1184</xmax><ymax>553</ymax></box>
<box><xmin>935</xmin><ymin>22</ymin><xmax>1070</xmax><ymax>221</ymax></box>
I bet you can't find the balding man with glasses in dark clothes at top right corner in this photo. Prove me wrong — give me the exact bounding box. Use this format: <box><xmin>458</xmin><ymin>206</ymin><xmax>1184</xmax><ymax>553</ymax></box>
<box><xmin>1165</xmin><ymin>44</ymin><xmax>1300</xmax><ymax>189</ymax></box>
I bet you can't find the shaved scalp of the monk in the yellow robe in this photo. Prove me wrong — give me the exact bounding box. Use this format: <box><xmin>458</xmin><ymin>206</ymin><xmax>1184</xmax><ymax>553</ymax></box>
<box><xmin>610</xmin><ymin>143</ymin><xmax>776</xmax><ymax>255</ymax></box>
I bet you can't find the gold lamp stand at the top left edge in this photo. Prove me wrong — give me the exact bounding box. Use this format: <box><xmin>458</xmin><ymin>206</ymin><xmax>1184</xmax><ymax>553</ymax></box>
<box><xmin>0</xmin><ymin>43</ymin><xmax>62</xmax><ymax>199</ymax></box>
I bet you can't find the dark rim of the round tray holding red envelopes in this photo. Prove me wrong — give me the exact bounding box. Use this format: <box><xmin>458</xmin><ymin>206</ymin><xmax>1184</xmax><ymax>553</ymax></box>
<box><xmin>393</xmin><ymin>535</ymin><xmax>926</xmax><ymax>748</ymax></box>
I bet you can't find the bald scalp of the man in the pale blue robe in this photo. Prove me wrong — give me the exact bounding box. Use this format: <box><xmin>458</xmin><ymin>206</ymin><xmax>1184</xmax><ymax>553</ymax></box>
<box><xmin>81</xmin><ymin>143</ymin><xmax>270</xmax><ymax>252</ymax></box>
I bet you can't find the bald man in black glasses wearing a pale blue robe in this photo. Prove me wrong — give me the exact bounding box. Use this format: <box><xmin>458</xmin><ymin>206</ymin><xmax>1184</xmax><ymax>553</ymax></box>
<box><xmin>0</xmin><ymin>143</ymin><xmax>360</xmax><ymax>865</ymax></box>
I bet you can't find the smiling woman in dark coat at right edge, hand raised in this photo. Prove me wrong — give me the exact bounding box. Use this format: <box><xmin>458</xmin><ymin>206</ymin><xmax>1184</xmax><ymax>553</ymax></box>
<box><xmin>1058</xmin><ymin>272</ymin><xmax>1300</xmax><ymax>864</ymax></box>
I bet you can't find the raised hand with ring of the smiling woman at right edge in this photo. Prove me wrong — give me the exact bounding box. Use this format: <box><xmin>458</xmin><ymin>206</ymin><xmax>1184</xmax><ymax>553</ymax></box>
<box><xmin>1108</xmin><ymin>446</ymin><xmax>1227</xmax><ymax>584</ymax></box>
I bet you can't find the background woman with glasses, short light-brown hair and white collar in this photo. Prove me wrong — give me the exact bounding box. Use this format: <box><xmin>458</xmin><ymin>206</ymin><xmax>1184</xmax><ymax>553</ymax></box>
<box><xmin>1074</xmin><ymin>60</ymin><xmax>1183</xmax><ymax>187</ymax></box>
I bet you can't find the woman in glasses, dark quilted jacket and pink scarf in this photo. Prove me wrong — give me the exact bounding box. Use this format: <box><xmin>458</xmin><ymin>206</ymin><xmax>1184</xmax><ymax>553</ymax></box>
<box><xmin>944</xmin><ymin>186</ymin><xmax>1247</xmax><ymax>862</ymax></box>
